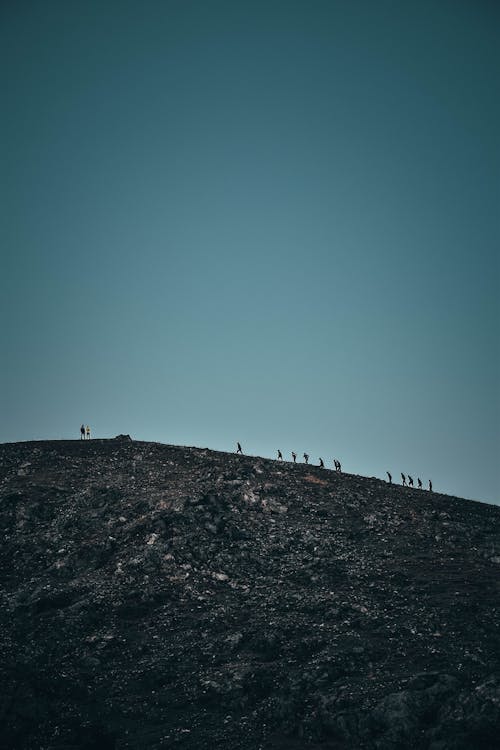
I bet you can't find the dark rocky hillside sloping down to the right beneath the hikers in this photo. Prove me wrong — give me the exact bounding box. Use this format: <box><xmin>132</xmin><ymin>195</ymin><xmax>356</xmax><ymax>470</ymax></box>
<box><xmin>0</xmin><ymin>436</ymin><xmax>500</xmax><ymax>750</ymax></box>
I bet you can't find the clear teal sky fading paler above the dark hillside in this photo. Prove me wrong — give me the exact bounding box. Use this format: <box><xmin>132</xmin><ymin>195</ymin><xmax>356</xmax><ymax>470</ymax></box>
<box><xmin>0</xmin><ymin>0</ymin><xmax>500</xmax><ymax>503</ymax></box>
